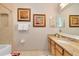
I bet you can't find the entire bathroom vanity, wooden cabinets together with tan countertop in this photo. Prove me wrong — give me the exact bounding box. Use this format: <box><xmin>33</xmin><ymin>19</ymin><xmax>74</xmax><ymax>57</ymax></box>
<box><xmin>48</xmin><ymin>34</ymin><xmax>79</xmax><ymax>56</ymax></box>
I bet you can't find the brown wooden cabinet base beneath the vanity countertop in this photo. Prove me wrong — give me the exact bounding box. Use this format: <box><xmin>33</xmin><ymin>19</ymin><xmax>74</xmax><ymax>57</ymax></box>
<box><xmin>48</xmin><ymin>36</ymin><xmax>72</xmax><ymax>56</ymax></box>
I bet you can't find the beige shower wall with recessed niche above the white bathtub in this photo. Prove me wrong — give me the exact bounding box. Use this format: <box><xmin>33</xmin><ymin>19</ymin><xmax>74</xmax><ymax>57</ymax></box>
<box><xmin>0</xmin><ymin>5</ymin><xmax>13</xmax><ymax>44</ymax></box>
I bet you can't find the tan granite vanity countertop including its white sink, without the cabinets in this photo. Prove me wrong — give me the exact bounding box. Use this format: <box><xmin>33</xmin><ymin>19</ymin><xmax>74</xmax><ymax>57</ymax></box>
<box><xmin>48</xmin><ymin>35</ymin><xmax>79</xmax><ymax>56</ymax></box>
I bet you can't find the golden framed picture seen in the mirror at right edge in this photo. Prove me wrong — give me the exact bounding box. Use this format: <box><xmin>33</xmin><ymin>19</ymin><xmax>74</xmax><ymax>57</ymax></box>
<box><xmin>69</xmin><ymin>15</ymin><xmax>79</xmax><ymax>27</ymax></box>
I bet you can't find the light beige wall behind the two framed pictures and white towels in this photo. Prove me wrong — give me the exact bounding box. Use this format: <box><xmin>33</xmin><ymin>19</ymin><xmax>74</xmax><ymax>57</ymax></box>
<box><xmin>1</xmin><ymin>3</ymin><xmax>58</xmax><ymax>50</ymax></box>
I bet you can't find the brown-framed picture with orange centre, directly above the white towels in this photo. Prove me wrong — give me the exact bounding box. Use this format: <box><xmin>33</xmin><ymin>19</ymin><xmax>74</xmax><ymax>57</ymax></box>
<box><xmin>17</xmin><ymin>8</ymin><xmax>31</xmax><ymax>21</ymax></box>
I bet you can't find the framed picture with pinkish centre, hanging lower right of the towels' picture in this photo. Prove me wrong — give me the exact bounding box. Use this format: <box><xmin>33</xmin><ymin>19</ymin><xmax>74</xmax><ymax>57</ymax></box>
<box><xmin>33</xmin><ymin>14</ymin><xmax>46</xmax><ymax>27</ymax></box>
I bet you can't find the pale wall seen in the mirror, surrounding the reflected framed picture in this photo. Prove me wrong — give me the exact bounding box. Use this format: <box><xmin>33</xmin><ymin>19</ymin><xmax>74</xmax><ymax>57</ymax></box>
<box><xmin>61</xmin><ymin>3</ymin><xmax>79</xmax><ymax>35</ymax></box>
